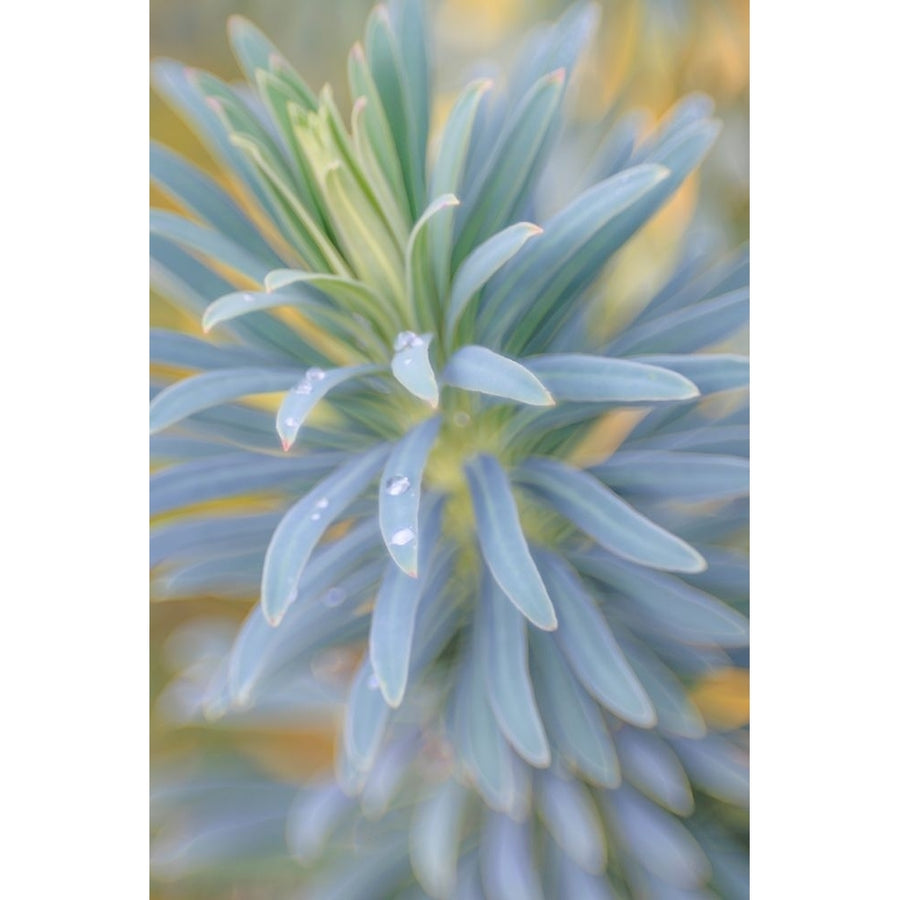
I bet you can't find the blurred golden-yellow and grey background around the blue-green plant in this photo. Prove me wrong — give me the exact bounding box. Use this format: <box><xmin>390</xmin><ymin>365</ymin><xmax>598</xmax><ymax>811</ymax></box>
<box><xmin>150</xmin><ymin>0</ymin><xmax>749</xmax><ymax>900</ymax></box>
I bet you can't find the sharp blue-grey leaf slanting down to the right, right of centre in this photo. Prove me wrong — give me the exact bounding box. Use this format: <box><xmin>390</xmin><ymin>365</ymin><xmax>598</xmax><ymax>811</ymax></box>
<box><xmin>515</xmin><ymin>458</ymin><xmax>706</xmax><ymax>572</ymax></box>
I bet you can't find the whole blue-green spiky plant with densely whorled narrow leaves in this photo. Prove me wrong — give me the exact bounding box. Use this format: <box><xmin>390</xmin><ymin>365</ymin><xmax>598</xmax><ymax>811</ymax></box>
<box><xmin>151</xmin><ymin>2</ymin><xmax>748</xmax><ymax>900</ymax></box>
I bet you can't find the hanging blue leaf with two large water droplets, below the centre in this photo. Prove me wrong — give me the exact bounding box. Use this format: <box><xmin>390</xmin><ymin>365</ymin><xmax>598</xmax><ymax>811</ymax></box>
<box><xmin>378</xmin><ymin>417</ymin><xmax>441</xmax><ymax>578</ymax></box>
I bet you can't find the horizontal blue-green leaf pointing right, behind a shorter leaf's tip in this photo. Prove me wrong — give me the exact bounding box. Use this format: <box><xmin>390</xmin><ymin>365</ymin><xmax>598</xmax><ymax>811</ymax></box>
<box><xmin>523</xmin><ymin>353</ymin><xmax>699</xmax><ymax>403</ymax></box>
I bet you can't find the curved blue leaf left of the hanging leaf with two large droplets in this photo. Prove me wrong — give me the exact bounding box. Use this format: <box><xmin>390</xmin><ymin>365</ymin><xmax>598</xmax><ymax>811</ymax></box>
<box><xmin>260</xmin><ymin>447</ymin><xmax>387</xmax><ymax>625</ymax></box>
